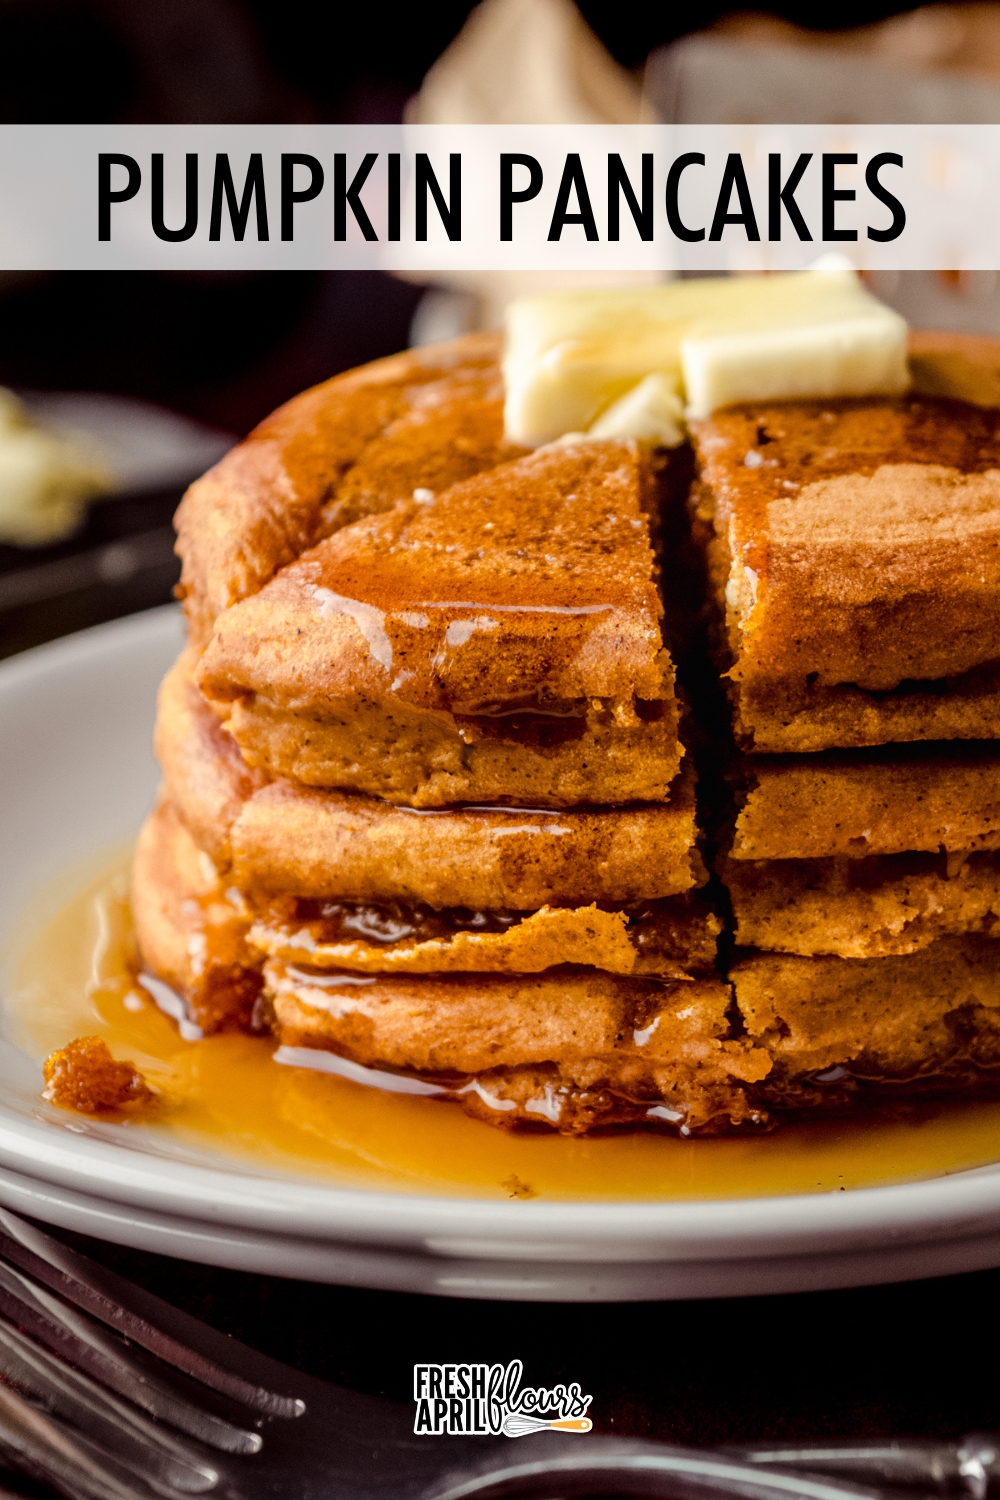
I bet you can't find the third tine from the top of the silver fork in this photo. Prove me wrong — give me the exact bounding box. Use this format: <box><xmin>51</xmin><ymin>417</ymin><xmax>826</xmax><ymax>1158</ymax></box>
<box><xmin>0</xmin><ymin>1320</ymin><xmax>219</xmax><ymax>1494</ymax></box>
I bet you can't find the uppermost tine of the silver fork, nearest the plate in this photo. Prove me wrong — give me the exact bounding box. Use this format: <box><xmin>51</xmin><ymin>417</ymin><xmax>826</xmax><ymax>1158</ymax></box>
<box><xmin>0</xmin><ymin>1209</ymin><xmax>306</xmax><ymax>1418</ymax></box>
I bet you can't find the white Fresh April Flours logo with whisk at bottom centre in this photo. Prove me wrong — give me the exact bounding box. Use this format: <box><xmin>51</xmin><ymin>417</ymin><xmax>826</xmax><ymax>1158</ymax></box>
<box><xmin>414</xmin><ymin>1359</ymin><xmax>594</xmax><ymax>1437</ymax></box>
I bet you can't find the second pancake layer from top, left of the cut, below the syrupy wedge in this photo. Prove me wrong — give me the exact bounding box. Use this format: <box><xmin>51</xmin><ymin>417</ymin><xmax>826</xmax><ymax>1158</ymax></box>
<box><xmin>229</xmin><ymin>779</ymin><xmax>703</xmax><ymax>911</ymax></box>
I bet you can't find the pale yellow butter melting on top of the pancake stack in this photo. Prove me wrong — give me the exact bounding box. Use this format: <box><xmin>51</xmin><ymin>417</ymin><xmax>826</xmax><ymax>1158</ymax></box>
<box><xmin>504</xmin><ymin>270</ymin><xmax>907</xmax><ymax>446</ymax></box>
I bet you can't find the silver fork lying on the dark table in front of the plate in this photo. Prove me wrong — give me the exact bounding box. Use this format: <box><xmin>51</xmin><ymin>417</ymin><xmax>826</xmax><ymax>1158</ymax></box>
<box><xmin>0</xmin><ymin>1209</ymin><xmax>1000</xmax><ymax>1500</ymax></box>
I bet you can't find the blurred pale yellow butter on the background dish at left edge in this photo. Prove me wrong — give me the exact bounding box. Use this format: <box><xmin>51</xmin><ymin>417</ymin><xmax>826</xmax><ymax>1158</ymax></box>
<box><xmin>0</xmin><ymin>387</ymin><xmax>112</xmax><ymax>546</ymax></box>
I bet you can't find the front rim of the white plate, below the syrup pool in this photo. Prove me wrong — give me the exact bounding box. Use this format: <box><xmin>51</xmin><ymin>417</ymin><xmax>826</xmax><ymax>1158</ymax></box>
<box><xmin>0</xmin><ymin>1110</ymin><xmax>1000</xmax><ymax>1260</ymax></box>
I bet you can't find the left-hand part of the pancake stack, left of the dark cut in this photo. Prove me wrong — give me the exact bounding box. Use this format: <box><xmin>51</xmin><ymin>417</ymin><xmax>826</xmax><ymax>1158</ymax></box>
<box><xmin>133</xmin><ymin>339</ymin><xmax>762</xmax><ymax>1130</ymax></box>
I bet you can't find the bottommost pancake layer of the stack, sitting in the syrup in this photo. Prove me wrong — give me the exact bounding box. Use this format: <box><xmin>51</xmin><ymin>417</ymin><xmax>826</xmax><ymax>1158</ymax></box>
<box><xmin>135</xmin><ymin>806</ymin><xmax>1000</xmax><ymax>1133</ymax></box>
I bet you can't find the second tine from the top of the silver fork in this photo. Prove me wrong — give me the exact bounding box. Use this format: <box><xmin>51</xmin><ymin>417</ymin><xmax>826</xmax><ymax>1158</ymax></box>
<box><xmin>0</xmin><ymin>1260</ymin><xmax>262</xmax><ymax>1454</ymax></box>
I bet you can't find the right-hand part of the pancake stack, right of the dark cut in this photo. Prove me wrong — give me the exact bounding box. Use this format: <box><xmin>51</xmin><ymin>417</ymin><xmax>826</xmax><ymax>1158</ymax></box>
<box><xmin>694</xmin><ymin>339</ymin><xmax>1000</xmax><ymax>1104</ymax></box>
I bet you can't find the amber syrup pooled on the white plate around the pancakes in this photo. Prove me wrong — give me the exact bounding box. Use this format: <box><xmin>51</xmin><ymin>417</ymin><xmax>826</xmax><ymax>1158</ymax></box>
<box><xmin>6</xmin><ymin>855</ymin><xmax>1000</xmax><ymax>1202</ymax></box>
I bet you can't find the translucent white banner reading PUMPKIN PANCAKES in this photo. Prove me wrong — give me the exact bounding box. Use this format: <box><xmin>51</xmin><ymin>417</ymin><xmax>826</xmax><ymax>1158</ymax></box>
<box><xmin>0</xmin><ymin>125</ymin><xmax>1000</xmax><ymax>275</ymax></box>
